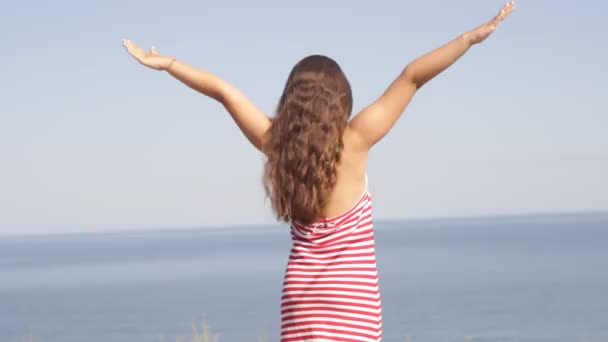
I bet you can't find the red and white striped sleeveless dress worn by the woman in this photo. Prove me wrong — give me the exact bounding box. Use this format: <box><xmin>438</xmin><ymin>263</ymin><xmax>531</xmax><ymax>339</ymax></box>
<box><xmin>281</xmin><ymin>175</ymin><xmax>382</xmax><ymax>342</ymax></box>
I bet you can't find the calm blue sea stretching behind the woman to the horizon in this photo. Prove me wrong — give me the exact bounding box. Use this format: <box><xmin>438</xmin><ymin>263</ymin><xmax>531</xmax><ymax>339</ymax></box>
<box><xmin>0</xmin><ymin>214</ymin><xmax>608</xmax><ymax>342</ymax></box>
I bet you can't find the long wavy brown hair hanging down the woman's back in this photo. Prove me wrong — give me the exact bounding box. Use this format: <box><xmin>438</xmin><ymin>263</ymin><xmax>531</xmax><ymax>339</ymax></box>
<box><xmin>263</xmin><ymin>55</ymin><xmax>353</xmax><ymax>224</ymax></box>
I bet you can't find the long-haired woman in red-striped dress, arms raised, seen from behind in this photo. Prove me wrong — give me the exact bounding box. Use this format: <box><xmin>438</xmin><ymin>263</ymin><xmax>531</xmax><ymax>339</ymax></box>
<box><xmin>123</xmin><ymin>1</ymin><xmax>515</xmax><ymax>342</ymax></box>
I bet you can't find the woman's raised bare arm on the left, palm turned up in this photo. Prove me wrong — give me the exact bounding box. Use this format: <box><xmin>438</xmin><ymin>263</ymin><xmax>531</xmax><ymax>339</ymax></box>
<box><xmin>123</xmin><ymin>40</ymin><xmax>271</xmax><ymax>151</ymax></box>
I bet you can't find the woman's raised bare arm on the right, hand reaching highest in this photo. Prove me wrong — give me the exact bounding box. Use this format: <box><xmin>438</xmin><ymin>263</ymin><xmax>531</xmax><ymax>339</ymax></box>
<box><xmin>349</xmin><ymin>1</ymin><xmax>515</xmax><ymax>149</ymax></box>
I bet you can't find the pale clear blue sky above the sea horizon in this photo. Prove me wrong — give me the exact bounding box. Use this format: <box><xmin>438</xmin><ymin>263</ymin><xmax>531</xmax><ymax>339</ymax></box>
<box><xmin>0</xmin><ymin>0</ymin><xmax>608</xmax><ymax>235</ymax></box>
